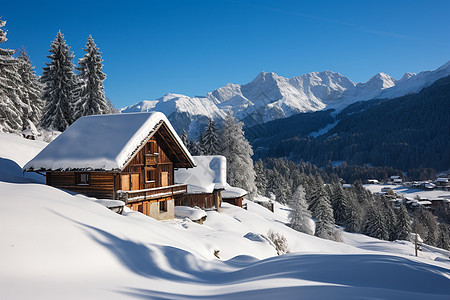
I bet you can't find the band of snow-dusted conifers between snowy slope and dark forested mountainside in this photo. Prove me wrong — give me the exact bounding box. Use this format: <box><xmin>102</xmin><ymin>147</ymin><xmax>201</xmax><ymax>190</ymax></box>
<box><xmin>255</xmin><ymin>158</ymin><xmax>450</xmax><ymax>249</ymax></box>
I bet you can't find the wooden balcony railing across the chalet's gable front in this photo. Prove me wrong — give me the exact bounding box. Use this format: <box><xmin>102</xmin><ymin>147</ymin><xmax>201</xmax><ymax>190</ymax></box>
<box><xmin>116</xmin><ymin>184</ymin><xmax>187</xmax><ymax>204</ymax></box>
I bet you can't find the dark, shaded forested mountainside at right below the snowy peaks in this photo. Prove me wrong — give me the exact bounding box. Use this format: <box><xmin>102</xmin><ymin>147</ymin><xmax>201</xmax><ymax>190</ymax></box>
<box><xmin>251</xmin><ymin>77</ymin><xmax>450</xmax><ymax>170</ymax></box>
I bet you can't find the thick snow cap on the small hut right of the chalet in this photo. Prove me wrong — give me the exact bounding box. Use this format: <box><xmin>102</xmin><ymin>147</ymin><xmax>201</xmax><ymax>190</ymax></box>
<box><xmin>175</xmin><ymin>155</ymin><xmax>227</xmax><ymax>194</ymax></box>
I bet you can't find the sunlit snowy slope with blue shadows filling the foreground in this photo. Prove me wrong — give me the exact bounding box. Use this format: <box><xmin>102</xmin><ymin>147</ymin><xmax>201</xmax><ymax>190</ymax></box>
<box><xmin>0</xmin><ymin>133</ymin><xmax>450</xmax><ymax>299</ymax></box>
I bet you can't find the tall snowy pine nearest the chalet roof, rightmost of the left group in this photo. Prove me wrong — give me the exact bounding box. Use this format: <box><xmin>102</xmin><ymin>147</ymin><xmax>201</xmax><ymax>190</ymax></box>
<box><xmin>74</xmin><ymin>35</ymin><xmax>110</xmax><ymax>120</ymax></box>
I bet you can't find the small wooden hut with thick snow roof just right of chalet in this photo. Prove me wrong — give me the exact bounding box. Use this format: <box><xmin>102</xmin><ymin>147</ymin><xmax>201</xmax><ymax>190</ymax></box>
<box><xmin>175</xmin><ymin>155</ymin><xmax>227</xmax><ymax>210</ymax></box>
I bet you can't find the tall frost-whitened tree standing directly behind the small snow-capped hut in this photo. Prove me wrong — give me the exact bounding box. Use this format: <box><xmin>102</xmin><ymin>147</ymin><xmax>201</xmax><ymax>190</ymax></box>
<box><xmin>220</xmin><ymin>112</ymin><xmax>256</xmax><ymax>198</ymax></box>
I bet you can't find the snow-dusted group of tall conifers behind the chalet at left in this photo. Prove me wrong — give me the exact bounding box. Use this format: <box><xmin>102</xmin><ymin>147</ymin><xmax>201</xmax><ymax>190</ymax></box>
<box><xmin>0</xmin><ymin>20</ymin><xmax>115</xmax><ymax>132</ymax></box>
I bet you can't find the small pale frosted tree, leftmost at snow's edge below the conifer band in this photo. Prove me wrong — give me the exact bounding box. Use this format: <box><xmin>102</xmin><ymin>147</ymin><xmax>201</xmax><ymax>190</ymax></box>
<box><xmin>289</xmin><ymin>185</ymin><xmax>314</xmax><ymax>235</ymax></box>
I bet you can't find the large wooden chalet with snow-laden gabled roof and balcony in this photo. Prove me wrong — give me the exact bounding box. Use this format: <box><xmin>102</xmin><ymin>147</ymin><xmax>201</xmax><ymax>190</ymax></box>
<box><xmin>24</xmin><ymin>112</ymin><xmax>194</xmax><ymax>220</ymax></box>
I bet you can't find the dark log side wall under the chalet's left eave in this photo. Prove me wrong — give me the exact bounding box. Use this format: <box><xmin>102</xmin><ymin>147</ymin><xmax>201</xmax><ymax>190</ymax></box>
<box><xmin>46</xmin><ymin>172</ymin><xmax>115</xmax><ymax>199</ymax></box>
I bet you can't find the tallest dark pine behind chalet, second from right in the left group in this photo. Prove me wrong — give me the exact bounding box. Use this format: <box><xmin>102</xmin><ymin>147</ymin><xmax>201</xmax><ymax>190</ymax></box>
<box><xmin>41</xmin><ymin>31</ymin><xmax>78</xmax><ymax>131</ymax></box>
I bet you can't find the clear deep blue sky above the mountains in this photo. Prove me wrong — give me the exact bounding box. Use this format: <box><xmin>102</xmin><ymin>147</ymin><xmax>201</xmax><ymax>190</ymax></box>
<box><xmin>0</xmin><ymin>0</ymin><xmax>450</xmax><ymax>108</ymax></box>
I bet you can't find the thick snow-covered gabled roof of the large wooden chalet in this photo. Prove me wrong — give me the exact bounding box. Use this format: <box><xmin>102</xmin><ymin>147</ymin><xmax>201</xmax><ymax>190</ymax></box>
<box><xmin>24</xmin><ymin>112</ymin><xmax>194</xmax><ymax>171</ymax></box>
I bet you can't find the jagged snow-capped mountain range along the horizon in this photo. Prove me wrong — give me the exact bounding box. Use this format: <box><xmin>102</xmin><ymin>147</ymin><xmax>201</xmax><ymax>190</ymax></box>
<box><xmin>121</xmin><ymin>61</ymin><xmax>450</xmax><ymax>137</ymax></box>
